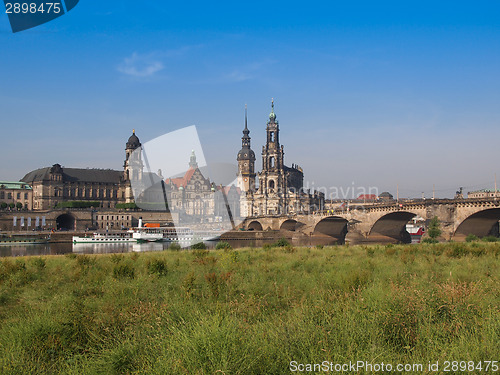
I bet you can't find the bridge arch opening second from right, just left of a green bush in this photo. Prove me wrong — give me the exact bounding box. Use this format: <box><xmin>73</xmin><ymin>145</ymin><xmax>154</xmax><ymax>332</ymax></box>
<box><xmin>368</xmin><ymin>211</ymin><xmax>417</xmax><ymax>243</ymax></box>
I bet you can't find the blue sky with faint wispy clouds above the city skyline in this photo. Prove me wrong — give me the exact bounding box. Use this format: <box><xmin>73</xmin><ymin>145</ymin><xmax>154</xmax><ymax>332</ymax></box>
<box><xmin>0</xmin><ymin>0</ymin><xmax>500</xmax><ymax>200</ymax></box>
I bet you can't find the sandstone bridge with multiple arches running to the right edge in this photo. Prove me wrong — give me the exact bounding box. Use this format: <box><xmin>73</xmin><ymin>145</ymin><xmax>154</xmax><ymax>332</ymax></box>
<box><xmin>240</xmin><ymin>198</ymin><xmax>500</xmax><ymax>243</ymax></box>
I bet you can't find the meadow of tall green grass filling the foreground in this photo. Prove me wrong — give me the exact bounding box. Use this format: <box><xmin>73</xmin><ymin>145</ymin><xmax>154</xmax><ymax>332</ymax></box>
<box><xmin>0</xmin><ymin>242</ymin><xmax>500</xmax><ymax>374</ymax></box>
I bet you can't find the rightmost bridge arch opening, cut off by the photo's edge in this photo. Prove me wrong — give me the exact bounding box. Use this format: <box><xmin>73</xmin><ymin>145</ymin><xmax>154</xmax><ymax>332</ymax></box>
<box><xmin>454</xmin><ymin>208</ymin><xmax>500</xmax><ymax>238</ymax></box>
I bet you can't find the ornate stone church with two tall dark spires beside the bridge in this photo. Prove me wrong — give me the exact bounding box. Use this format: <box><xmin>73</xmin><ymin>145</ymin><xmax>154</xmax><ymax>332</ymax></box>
<box><xmin>237</xmin><ymin>100</ymin><xmax>325</xmax><ymax>216</ymax></box>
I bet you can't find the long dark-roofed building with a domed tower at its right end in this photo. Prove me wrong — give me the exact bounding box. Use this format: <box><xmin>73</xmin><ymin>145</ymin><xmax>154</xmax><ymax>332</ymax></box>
<box><xmin>21</xmin><ymin>131</ymin><xmax>142</xmax><ymax>210</ymax></box>
